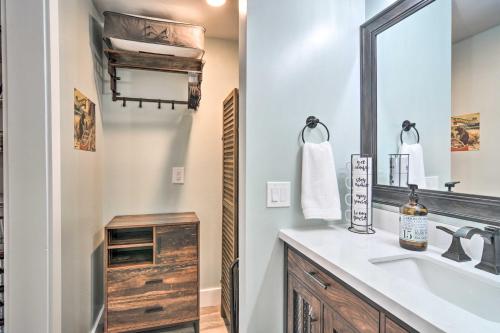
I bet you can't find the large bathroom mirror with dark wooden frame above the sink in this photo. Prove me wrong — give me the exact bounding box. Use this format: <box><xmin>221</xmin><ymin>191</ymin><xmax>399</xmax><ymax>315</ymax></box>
<box><xmin>361</xmin><ymin>0</ymin><xmax>500</xmax><ymax>225</ymax></box>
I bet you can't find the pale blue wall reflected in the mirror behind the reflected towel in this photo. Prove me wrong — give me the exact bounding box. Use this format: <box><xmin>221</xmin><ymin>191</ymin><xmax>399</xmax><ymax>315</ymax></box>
<box><xmin>377</xmin><ymin>0</ymin><xmax>451</xmax><ymax>189</ymax></box>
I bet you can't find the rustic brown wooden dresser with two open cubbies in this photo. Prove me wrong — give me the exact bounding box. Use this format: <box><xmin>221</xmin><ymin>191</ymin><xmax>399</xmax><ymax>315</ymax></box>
<box><xmin>104</xmin><ymin>213</ymin><xmax>200</xmax><ymax>333</ymax></box>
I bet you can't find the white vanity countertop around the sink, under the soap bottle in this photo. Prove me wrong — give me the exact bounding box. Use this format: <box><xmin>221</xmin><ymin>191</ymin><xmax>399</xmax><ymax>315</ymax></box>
<box><xmin>279</xmin><ymin>225</ymin><xmax>500</xmax><ymax>333</ymax></box>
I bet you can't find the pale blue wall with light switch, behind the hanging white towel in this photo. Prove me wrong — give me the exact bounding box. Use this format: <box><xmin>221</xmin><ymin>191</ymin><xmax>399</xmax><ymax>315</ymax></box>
<box><xmin>240</xmin><ymin>0</ymin><xmax>364</xmax><ymax>333</ymax></box>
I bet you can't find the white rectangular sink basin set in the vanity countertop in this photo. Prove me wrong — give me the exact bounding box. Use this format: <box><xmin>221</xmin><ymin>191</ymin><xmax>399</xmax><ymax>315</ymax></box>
<box><xmin>369</xmin><ymin>255</ymin><xmax>500</xmax><ymax>323</ymax></box>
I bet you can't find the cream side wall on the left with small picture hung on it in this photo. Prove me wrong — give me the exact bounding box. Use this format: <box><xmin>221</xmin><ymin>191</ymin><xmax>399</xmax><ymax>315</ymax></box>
<box><xmin>59</xmin><ymin>0</ymin><xmax>105</xmax><ymax>332</ymax></box>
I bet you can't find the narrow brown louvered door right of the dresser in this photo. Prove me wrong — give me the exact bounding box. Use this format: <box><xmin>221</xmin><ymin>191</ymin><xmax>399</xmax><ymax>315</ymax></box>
<box><xmin>221</xmin><ymin>89</ymin><xmax>238</xmax><ymax>321</ymax></box>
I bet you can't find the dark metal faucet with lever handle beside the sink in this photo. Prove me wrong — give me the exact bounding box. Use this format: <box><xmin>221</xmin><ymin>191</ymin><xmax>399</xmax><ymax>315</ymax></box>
<box><xmin>436</xmin><ymin>226</ymin><xmax>500</xmax><ymax>275</ymax></box>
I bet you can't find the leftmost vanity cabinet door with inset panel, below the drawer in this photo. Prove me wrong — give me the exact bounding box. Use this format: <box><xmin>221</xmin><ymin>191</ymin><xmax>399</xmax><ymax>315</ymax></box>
<box><xmin>287</xmin><ymin>274</ymin><xmax>321</xmax><ymax>333</ymax></box>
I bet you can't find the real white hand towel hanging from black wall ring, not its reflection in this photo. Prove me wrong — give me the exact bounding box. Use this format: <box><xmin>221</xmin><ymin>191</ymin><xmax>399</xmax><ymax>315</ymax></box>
<box><xmin>302</xmin><ymin>142</ymin><xmax>342</xmax><ymax>220</ymax></box>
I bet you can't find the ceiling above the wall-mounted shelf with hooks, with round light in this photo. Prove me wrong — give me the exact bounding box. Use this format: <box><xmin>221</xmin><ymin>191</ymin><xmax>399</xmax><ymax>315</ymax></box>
<box><xmin>93</xmin><ymin>0</ymin><xmax>238</xmax><ymax>40</ymax></box>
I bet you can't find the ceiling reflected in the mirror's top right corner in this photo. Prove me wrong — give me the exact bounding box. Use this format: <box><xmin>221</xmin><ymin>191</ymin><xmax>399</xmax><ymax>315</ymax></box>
<box><xmin>453</xmin><ymin>0</ymin><xmax>500</xmax><ymax>42</ymax></box>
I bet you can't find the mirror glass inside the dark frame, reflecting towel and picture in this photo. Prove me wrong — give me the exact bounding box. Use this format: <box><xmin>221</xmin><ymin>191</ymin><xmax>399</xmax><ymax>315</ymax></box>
<box><xmin>377</xmin><ymin>0</ymin><xmax>500</xmax><ymax>197</ymax></box>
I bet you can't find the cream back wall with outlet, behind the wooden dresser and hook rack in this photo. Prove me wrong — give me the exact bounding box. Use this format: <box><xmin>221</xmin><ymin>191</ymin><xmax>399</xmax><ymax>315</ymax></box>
<box><xmin>102</xmin><ymin>38</ymin><xmax>238</xmax><ymax>289</ymax></box>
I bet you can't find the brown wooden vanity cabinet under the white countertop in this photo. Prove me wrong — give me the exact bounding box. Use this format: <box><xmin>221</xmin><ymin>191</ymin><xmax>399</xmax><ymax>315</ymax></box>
<box><xmin>285</xmin><ymin>246</ymin><xmax>415</xmax><ymax>333</ymax></box>
